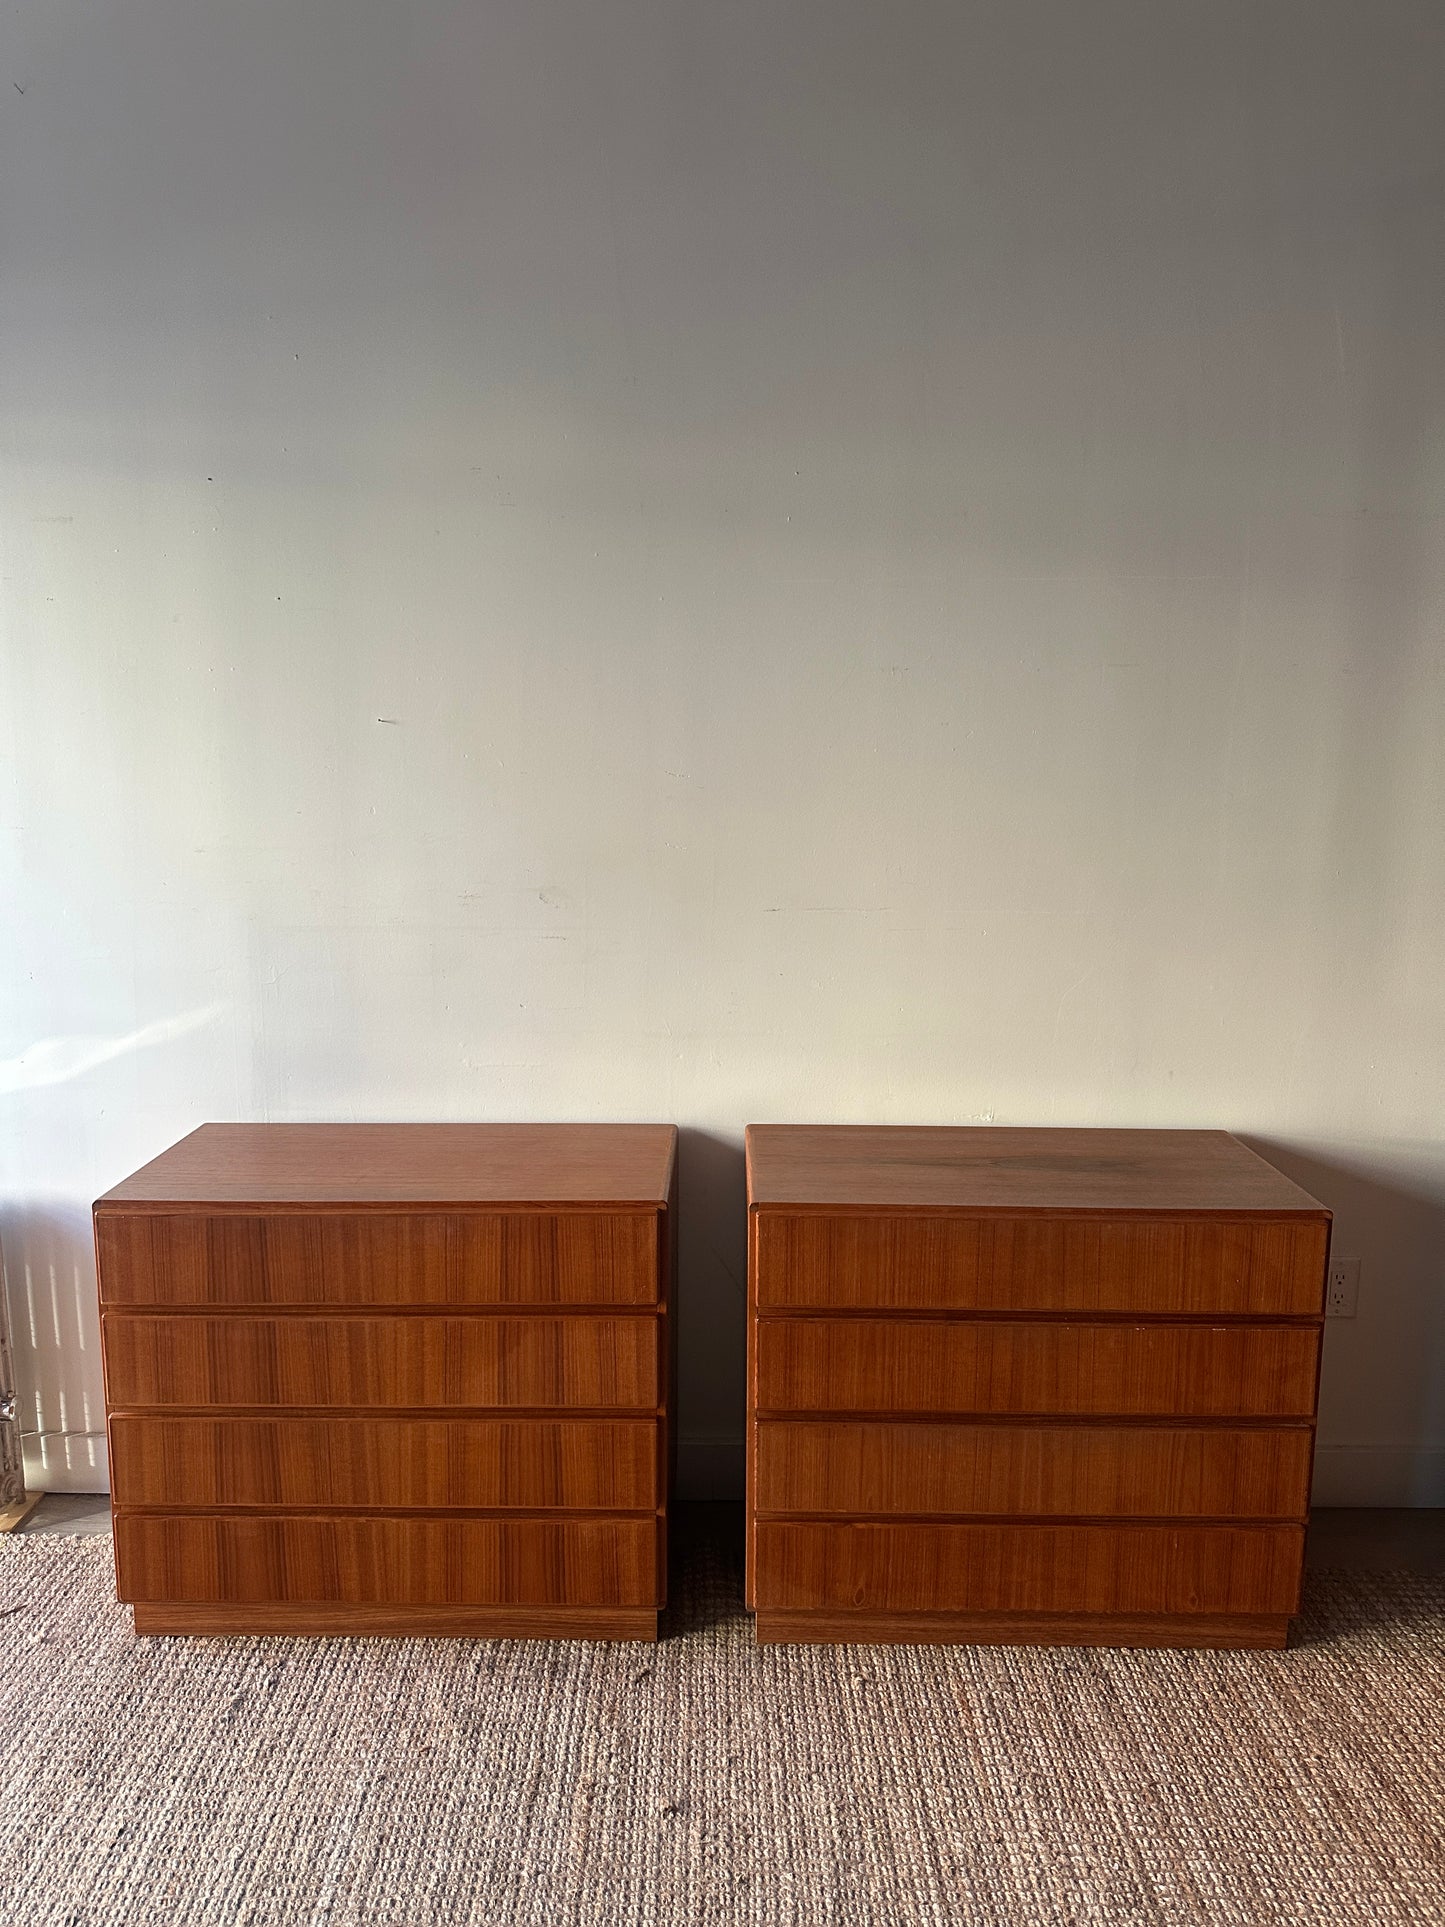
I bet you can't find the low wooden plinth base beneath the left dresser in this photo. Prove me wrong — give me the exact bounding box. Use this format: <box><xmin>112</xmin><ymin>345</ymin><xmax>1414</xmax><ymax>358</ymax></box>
<box><xmin>133</xmin><ymin>1605</ymin><xmax>657</xmax><ymax>1642</ymax></box>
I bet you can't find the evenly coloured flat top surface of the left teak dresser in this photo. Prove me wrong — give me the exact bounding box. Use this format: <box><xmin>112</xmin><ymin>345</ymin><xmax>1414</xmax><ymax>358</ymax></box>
<box><xmin>98</xmin><ymin>1123</ymin><xmax>676</xmax><ymax>1206</ymax></box>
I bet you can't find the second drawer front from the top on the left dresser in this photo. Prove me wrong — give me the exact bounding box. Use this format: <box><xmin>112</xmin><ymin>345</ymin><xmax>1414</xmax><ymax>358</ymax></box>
<box><xmin>102</xmin><ymin>1312</ymin><xmax>659</xmax><ymax>1411</ymax></box>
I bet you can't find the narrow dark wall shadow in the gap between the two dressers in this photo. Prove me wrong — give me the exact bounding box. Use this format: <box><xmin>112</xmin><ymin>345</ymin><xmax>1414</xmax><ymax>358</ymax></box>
<box><xmin>674</xmin><ymin>1129</ymin><xmax>748</xmax><ymax>1499</ymax></box>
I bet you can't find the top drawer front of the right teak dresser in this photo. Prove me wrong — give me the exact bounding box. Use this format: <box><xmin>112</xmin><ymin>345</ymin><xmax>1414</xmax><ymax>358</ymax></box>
<box><xmin>753</xmin><ymin>1210</ymin><xmax>1329</xmax><ymax>1318</ymax></box>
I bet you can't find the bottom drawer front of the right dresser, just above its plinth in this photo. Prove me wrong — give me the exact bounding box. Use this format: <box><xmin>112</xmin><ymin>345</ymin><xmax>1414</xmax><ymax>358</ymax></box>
<box><xmin>755</xmin><ymin>1520</ymin><xmax>1304</xmax><ymax>1613</ymax></box>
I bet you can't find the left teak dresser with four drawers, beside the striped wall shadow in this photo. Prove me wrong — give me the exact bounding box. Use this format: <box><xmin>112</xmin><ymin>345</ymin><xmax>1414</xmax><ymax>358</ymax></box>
<box><xmin>94</xmin><ymin>1123</ymin><xmax>676</xmax><ymax>1640</ymax></box>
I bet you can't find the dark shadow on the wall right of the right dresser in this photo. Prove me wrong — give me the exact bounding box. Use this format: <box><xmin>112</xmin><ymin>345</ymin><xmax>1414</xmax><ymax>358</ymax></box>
<box><xmin>1245</xmin><ymin>1137</ymin><xmax>1445</xmax><ymax>1505</ymax></box>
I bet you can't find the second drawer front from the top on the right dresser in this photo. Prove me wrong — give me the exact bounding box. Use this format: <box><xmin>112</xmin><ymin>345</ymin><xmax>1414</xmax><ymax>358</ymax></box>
<box><xmin>753</xmin><ymin>1318</ymin><xmax>1320</xmax><ymax>1418</ymax></box>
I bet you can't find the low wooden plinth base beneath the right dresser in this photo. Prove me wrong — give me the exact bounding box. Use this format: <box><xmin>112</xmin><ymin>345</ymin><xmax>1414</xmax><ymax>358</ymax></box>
<box><xmin>757</xmin><ymin>1613</ymin><xmax>1289</xmax><ymax>1650</ymax></box>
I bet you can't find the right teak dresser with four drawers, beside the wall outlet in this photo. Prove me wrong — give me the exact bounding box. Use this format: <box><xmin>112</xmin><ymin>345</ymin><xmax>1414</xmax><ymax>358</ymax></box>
<box><xmin>748</xmin><ymin>1125</ymin><xmax>1329</xmax><ymax>1646</ymax></box>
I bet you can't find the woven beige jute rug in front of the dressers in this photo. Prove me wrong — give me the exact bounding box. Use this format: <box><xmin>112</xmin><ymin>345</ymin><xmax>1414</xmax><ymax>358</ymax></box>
<box><xmin>0</xmin><ymin>1536</ymin><xmax>1445</xmax><ymax>1927</ymax></box>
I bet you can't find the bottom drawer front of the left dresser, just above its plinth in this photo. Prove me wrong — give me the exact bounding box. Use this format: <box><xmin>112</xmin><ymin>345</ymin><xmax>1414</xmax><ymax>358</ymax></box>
<box><xmin>116</xmin><ymin>1511</ymin><xmax>661</xmax><ymax>1605</ymax></box>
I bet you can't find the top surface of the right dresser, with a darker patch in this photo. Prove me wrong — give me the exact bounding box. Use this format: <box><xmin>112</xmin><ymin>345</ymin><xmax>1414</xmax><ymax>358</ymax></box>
<box><xmin>748</xmin><ymin>1123</ymin><xmax>1327</xmax><ymax>1218</ymax></box>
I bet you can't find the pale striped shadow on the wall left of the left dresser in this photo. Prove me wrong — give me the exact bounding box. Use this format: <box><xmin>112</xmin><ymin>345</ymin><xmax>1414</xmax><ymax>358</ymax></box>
<box><xmin>0</xmin><ymin>1202</ymin><xmax>110</xmax><ymax>1491</ymax></box>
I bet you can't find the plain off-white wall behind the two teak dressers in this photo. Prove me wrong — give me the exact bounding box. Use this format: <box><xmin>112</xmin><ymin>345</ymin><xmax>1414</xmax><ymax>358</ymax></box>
<box><xmin>0</xmin><ymin>0</ymin><xmax>1445</xmax><ymax>1503</ymax></box>
